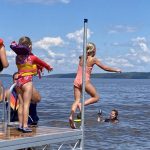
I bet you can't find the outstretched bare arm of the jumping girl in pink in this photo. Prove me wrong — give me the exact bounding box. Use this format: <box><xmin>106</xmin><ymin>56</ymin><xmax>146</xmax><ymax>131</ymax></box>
<box><xmin>93</xmin><ymin>58</ymin><xmax>121</xmax><ymax>73</ymax></box>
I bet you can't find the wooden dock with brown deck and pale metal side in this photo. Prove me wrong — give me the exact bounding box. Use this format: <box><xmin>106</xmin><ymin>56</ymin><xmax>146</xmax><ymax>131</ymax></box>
<box><xmin>0</xmin><ymin>126</ymin><xmax>82</xmax><ymax>150</ymax></box>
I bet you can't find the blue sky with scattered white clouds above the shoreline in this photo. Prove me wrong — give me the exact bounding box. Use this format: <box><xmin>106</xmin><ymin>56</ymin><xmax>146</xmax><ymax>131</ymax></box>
<box><xmin>0</xmin><ymin>0</ymin><xmax>150</xmax><ymax>74</ymax></box>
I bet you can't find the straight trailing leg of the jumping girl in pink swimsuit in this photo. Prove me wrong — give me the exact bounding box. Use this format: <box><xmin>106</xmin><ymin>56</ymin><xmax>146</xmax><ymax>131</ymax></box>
<box><xmin>69</xmin><ymin>86</ymin><xmax>81</xmax><ymax>129</ymax></box>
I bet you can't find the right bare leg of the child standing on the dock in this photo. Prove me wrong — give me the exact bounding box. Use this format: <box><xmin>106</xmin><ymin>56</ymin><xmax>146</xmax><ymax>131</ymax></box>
<box><xmin>22</xmin><ymin>82</ymin><xmax>33</xmax><ymax>128</ymax></box>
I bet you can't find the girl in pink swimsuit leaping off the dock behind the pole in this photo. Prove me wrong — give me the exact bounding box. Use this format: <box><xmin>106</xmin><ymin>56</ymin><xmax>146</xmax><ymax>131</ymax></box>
<box><xmin>69</xmin><ymin>42</ymin><xmax>121</xmax><ymax>129</ymax></box>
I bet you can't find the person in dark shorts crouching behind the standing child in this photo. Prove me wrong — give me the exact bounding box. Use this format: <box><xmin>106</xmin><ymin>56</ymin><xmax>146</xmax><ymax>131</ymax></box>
<box><xmin>5</xmin><ymin>72</ymin><xmax>41</xmax><ymax>125</ymax></box>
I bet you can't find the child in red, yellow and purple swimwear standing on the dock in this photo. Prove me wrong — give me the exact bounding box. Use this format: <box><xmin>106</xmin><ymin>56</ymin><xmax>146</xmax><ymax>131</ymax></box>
<box><xmin>10</xmin><ymin>37</ymin><xmax>53</xmax><ymax>133</ymax></box>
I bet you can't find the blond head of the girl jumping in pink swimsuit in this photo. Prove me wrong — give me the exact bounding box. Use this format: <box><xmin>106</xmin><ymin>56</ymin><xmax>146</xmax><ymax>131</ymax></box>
<box><xmin>86</xmin><ymin>42</ymin><xmax>96</xmax><ymax>57</ymax></box>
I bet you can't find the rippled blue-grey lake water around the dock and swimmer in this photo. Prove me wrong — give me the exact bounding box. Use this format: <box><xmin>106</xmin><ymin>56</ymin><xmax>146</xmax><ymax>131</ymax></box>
<box><xmin>0</xmin><ymin>77</ymin><xmax>150</xmax><ymax>150</ymax></box>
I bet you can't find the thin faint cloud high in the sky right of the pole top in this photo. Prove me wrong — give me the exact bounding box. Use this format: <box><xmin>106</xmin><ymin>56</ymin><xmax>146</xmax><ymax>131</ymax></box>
<box><xmin>108</xmin><ymin>25</ymin><xmax>136</xmax><ymax>34</ymax></box>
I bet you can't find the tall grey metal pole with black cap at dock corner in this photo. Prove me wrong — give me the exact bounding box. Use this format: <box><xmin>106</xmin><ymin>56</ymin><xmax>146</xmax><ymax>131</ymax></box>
<box><xmin>81</xmin><ymin>19</ymin><xmax>88</xmax><ymax>150</ymax></box>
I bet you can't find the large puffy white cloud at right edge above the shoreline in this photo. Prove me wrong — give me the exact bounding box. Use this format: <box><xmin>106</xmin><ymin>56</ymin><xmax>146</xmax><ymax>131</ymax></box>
<box><xmin>103</xmin><ymin>37</ymin><xmax>150</xmax><ymax>71</ymax></box>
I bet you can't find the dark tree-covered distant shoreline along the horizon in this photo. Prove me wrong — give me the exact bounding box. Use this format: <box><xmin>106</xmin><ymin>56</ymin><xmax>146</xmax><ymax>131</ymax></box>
<box><xmin>0</xmin><ymin>72</ymin><xmax>150</xmax><ymax>79</ymax></box>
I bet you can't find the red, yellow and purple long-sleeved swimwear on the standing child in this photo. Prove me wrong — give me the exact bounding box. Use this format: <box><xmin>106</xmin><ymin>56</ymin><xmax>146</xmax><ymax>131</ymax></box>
<box><xmin>10</xmin><ymin>42</ymin><xmax>52</xmax><ymax>88</ymax></box>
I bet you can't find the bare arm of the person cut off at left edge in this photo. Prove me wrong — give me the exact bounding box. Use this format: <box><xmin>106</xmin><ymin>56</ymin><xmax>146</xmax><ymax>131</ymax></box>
<box><xmin>0</xmin><ymin>46</ymin><xmax>9</xmax><ymax>68</ymax></box>
